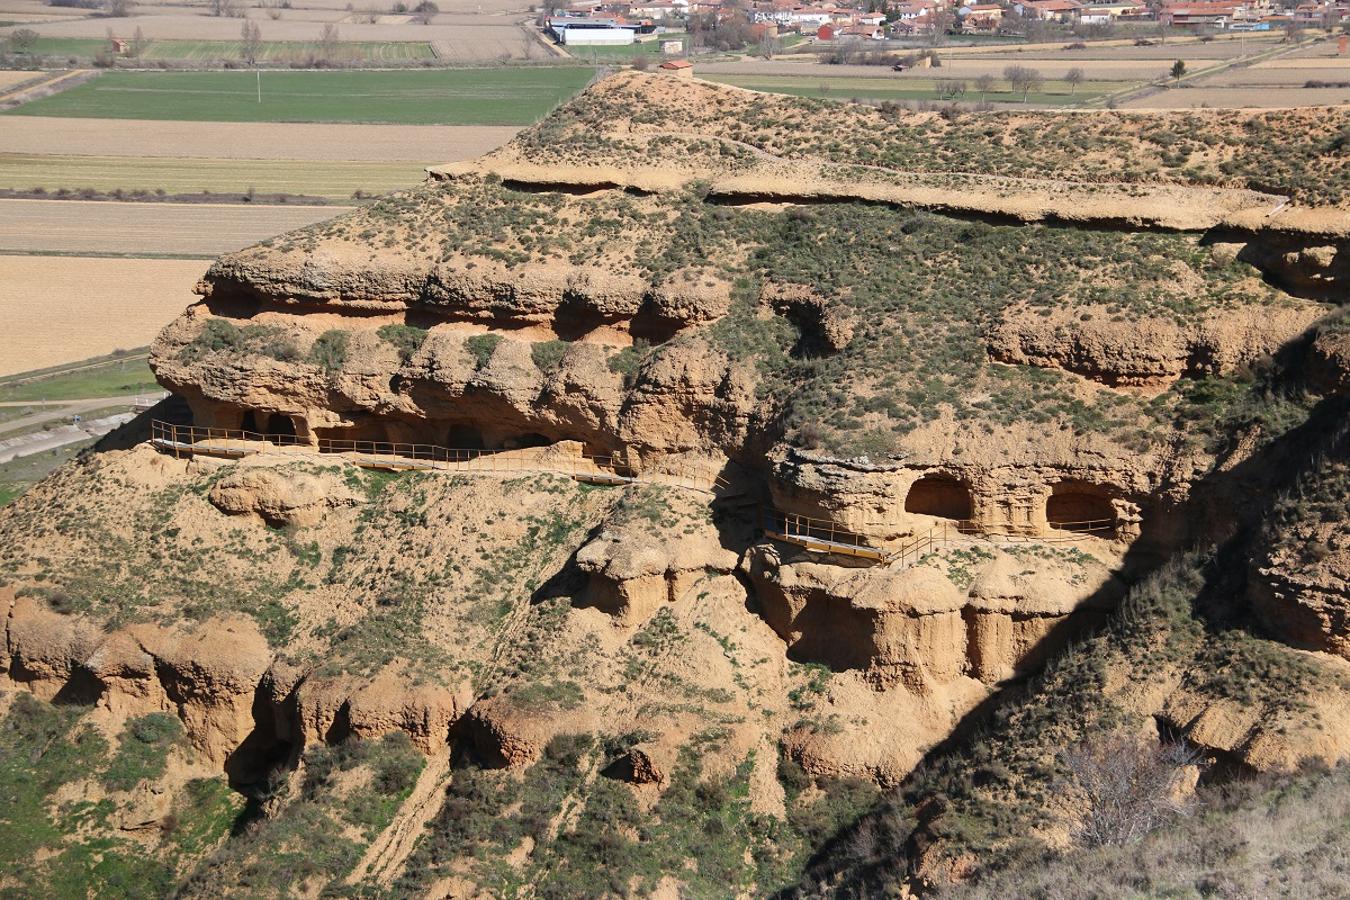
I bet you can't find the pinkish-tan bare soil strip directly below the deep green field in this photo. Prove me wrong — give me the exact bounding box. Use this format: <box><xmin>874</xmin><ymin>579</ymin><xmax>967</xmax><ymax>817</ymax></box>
<box><xmin>0</xmin><ymin>117</ymin><xmax>520</xmax><ymax>162</ymax></box>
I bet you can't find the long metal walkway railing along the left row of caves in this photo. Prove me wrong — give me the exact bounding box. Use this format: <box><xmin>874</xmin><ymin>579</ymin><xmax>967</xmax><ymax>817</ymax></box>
<box><xmin>150</xmin><ymin>420</ymin><xmax>728</xmax><ymax>493</ymax></box>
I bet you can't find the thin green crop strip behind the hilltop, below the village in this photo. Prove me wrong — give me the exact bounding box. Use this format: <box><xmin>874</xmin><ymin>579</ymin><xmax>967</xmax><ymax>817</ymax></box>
<box><xmin>699</xmin><ymin>74</ymin><xmax>1126</xmax><ymax>107</ymax></box>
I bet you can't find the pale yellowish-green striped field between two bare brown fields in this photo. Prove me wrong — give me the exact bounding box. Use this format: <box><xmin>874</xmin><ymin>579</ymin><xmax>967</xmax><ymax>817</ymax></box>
<box><xmin>0</xmin><ymin>154</ymin><xmax>427</xmax><ymax>200</ymax></box>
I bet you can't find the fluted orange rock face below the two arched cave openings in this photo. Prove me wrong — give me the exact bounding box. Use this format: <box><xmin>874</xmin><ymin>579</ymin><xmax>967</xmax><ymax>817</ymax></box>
<box><xmin>749</xmin><ymin>546</ymin><xmax>1123</xmax><ymax>692</ymax></box>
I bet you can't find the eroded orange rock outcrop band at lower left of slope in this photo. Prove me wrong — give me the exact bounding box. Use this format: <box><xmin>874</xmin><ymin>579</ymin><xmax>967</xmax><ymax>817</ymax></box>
<box><xmin>0</xmin><ymin>588</ymin><xmax>483</xmax><ymax>765</ymax></box>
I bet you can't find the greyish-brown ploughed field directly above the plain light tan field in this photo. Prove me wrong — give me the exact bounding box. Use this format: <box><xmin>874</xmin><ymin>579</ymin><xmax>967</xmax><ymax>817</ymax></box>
<box><xmin>0</xmin><ymin>200</ymin><xmax>347</xmax><ymax>258</ymax></box>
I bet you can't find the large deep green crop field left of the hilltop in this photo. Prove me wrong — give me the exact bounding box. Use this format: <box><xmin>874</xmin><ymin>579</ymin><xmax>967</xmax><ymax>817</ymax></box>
<box><xmin>4</xmin><ymin>66</ymin><xmax>593</xmax><ymax>124</ymax></box>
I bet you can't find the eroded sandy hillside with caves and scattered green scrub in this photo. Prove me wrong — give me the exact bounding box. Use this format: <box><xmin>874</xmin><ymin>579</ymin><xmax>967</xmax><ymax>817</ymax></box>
<box><xmin>0</xmin><ymin>73</ymin><xmax>1350</xmax><ymax>896</ymax></box>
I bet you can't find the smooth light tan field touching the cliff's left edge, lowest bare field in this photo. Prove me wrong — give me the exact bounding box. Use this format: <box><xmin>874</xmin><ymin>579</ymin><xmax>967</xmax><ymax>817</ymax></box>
<box><xmin>0</xmin><ymin>256</ymin><xmax>207</xmax><ymax>375</ymax></box>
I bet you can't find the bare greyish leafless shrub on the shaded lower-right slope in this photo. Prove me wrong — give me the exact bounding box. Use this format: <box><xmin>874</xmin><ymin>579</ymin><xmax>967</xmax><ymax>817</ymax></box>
<box><xmin>1060</xmin><ymin>731</ymin><xmax>1199</xmax><ymax>847</ymax></box>
